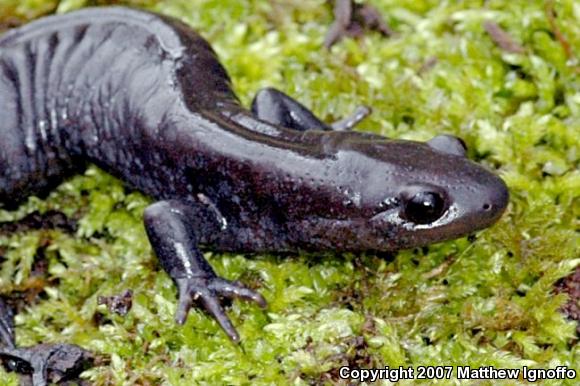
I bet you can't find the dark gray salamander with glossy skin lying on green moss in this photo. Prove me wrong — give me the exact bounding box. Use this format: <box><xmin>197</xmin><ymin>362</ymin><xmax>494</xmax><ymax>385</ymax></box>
<box><xmin>0</xmin><ymin>4</ymin><xmax>508</xmax><ymax>354</ymax></box>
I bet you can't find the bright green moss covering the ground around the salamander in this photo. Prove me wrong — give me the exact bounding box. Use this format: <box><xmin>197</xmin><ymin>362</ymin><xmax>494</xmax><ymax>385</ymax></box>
<box><xmin>0</xmin><ymin>0</ymin><xmax>580</xmax><ymax>385</ymax></box>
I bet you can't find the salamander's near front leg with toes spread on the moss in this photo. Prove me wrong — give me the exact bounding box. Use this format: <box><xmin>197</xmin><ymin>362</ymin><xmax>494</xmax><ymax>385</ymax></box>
<box><xmin>145</xmin><ymin>201</ymin><xmax>266</xmax><ymax>342</ymax></box>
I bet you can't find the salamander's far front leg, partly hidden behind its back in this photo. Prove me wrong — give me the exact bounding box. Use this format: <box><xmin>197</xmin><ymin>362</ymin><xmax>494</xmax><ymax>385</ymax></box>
<box><xmin>252</xmin><ymin>88</ymin><xmax>371</xmax><ymax>131</ymax></box>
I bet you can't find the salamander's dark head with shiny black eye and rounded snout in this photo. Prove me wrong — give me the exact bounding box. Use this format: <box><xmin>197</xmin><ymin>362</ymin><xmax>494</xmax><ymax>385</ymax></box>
<box><xmin>326</xmin><ymin>136</ymin><xmax>509</xmax><ymax>250</ymax></box>
